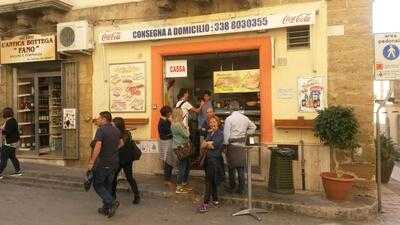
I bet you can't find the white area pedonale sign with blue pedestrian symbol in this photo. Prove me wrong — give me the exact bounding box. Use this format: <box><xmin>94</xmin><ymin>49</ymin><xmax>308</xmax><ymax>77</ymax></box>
<box><xmin>375</xmin><ymin>33</ymin><xmax>400</xmax><ymax>80</ymax></box>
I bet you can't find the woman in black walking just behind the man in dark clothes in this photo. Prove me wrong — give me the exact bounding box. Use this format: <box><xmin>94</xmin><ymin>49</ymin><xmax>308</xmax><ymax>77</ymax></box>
<box><xmin>112</xmin><ymin>117</ymin><xmax>140</xmax><ymax>204</ymax></box>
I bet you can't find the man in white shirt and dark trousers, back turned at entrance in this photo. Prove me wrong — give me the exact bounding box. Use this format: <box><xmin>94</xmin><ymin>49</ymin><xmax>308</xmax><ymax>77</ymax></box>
<box><xmin>224</xmin><ymin>100</ymin><xmax>257</xmax><ymax>194</ymax></box>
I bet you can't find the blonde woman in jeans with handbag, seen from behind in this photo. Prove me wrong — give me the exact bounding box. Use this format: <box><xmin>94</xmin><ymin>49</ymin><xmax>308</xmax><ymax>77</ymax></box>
<box><xmin>171</xmin><ymin>108</ymin><xmax>192</xmax><ymax>194</ymax></box>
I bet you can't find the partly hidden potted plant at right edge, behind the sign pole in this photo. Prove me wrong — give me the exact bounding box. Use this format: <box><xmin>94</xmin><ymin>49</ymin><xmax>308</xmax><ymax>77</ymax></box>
<box><xmin>375</xmin><ymin>134</ymin><xmax>400</xmax><ymax>184</ymax></box>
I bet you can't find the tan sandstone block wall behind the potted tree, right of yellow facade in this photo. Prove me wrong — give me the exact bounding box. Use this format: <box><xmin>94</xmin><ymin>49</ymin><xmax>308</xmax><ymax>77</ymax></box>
<box><xmin>328</xmin><ymin>0</ymin><xmax>375</xmax><ymax>185</ymax></box>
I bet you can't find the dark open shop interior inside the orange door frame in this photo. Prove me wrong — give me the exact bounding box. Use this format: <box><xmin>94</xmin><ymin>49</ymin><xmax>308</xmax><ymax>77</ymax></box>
<box><xmin>164</xmin><ymin>50</ymin><xmax>261</xmax><ymax>171</ymax></box>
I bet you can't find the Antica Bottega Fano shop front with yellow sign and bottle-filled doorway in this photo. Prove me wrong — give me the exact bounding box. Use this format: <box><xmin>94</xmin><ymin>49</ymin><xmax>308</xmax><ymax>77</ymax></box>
<box><xmin>0</xmin><ymin>1</ymin><xmax>92</xmax><ymax>165</ymax></box>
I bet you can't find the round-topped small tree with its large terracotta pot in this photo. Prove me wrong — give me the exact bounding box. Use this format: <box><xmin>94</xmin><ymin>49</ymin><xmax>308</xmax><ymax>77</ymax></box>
<box><xmin>314</xmin><ymin>106</ymin><xmax>359</xmax><ymax>201</ymax></box>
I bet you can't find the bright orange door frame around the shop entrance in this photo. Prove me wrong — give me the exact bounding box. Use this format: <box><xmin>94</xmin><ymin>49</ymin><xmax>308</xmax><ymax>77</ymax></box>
<box><xmin>151</xmin><ymin>36</ymin><xmax>272</xmax><ymax>179</ymax></box>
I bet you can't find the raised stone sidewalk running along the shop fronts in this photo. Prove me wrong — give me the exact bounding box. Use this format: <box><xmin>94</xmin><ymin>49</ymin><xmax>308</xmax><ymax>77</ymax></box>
<box><xmin>1</xmin><ymin>163</ymin><xmax>376</xmax><ymax>220</ymax></box>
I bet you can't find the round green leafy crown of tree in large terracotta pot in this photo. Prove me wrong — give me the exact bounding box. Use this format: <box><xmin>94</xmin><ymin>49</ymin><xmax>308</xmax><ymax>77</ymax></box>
<box><xmin>314</xmin><ymin>106</ymin><xmax>359</xmax><ymax>151</ymax></box>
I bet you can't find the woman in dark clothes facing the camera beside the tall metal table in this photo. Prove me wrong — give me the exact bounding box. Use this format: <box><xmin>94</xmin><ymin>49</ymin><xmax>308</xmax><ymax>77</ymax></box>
<box><xmin>198</xmin><ymin>116</ymin><xmax>224</xmax><ymax>213</ymax></box>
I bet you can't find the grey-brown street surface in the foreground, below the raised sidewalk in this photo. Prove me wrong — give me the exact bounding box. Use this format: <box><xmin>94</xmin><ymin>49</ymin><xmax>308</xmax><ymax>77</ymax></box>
<box><xmin>0</xmin><ymin>182</ymin><xmax>384</xmax><ymax>225</ymax></box>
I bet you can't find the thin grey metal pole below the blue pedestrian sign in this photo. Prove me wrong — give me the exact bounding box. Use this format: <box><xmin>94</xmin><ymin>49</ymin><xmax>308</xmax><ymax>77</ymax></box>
<box><xmin>376</xmin><ymin>87</ymin><xmax>392</xmax><ymax>213</ymax></box>
